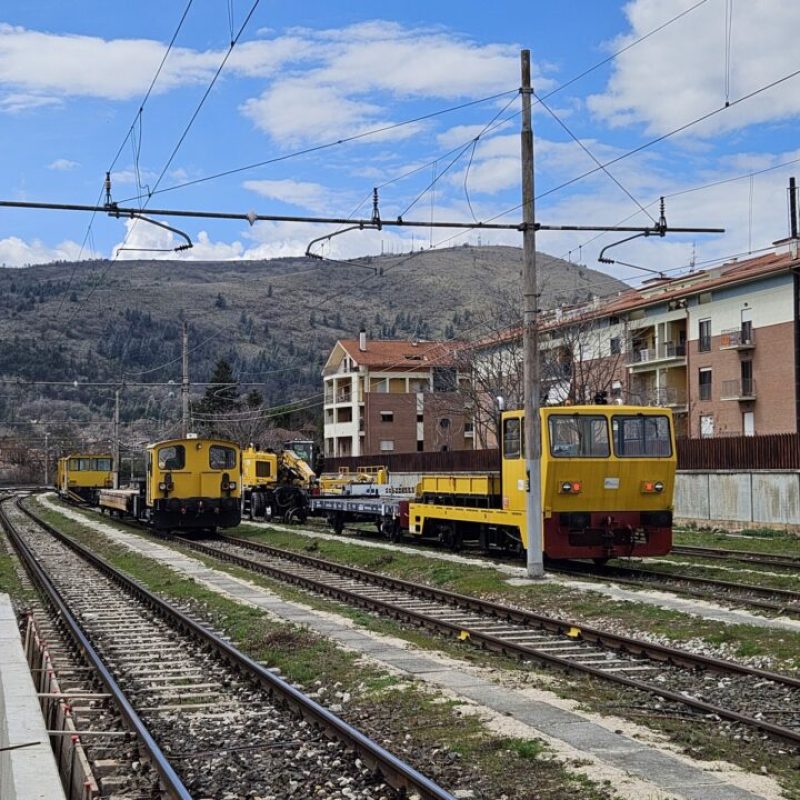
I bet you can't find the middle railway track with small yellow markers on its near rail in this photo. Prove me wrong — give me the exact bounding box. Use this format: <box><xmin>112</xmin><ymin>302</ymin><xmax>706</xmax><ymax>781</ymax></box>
<box><xmin>155</xmin><ymin>536</ymin><xmax>800</xmax><ymax>746</ymax></box>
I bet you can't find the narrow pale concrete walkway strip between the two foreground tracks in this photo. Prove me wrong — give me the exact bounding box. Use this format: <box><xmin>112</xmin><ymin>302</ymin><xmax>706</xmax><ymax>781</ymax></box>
<box><xmin>43</xmin><ymin>498</ymin><xmax>779</xmax><ymax>800</ymax></box>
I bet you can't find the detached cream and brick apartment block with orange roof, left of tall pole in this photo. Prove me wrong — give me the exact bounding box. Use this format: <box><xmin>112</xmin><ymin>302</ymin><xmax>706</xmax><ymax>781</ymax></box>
<box><xmin>322</xmin><ymin>331</ymin><xmax>473</xmax><ymax>457</ymax></box>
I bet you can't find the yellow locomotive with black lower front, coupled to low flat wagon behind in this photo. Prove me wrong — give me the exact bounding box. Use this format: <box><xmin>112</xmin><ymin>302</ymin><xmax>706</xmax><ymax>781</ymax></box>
<box><xmin>100</xmin><ymin>435</ymin><xmax>241</xmax><ymax>531</ymax></box>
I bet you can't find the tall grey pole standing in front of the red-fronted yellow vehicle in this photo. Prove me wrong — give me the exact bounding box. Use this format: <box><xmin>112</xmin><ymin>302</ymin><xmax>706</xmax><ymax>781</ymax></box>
<box><xmin>520</xmin><ymin>50</ymin><xmax>544</xmax><ymax>578</ymax></box>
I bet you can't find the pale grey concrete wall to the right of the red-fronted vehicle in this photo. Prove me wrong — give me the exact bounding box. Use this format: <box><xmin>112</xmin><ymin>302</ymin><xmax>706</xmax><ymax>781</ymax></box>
<box><xmin>675</xmin><ymin>470</ymin><xmax>800</xmax><ymax>532</ymax></box>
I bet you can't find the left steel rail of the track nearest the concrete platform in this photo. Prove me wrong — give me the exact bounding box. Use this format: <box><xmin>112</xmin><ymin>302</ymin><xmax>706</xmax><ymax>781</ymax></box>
<box><xmin>0</xmin><ymin>498</ymin><xmax>192</xmax><ymax>800</ymax></box>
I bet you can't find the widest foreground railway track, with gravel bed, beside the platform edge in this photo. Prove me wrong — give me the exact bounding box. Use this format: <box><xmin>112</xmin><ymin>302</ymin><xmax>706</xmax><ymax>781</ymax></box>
<box><xmin>0</xmin><ymin>500</ymin><xmax>452</xmax><ymax>800</ymax></box>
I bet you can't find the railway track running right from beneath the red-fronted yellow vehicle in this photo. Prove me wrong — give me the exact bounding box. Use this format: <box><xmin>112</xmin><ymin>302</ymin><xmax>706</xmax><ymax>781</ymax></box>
<box><xmin>548</xmin><ymin>562</ymin><xmax>800</xmax><ymax>618</ymax></box>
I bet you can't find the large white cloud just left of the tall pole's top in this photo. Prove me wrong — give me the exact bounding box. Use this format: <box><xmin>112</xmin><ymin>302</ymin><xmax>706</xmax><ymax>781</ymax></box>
<box><xmin>241</xmin><ymin>20</ymin><xmax>532</xmax><ymax>144</ymax></box>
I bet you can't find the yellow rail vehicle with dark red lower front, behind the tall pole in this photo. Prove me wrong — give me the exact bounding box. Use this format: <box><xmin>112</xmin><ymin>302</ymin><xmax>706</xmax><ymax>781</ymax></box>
<box><xmin>408</xmin><ymin>405</ymin><xmax>677</xmax><ymax>562</ymax></box>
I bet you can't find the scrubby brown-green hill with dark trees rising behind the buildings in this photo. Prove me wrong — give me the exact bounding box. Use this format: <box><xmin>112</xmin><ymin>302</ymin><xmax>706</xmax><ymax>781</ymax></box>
<box><xmin>0</xmin><ymin>246</ymin><xmax>625</xmax><ymax>444</ymax></box>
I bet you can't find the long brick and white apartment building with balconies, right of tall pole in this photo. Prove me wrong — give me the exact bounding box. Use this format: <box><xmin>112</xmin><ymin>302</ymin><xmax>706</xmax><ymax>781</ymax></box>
<box><xmin>479</xmin><ymin>239</ymin><xmax>800</xmax><ymax>438</ymax></box>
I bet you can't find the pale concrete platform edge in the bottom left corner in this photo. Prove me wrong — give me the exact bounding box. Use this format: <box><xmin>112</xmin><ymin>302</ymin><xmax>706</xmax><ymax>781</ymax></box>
<box><xmin>0</xmin><ymin>594</ymin><xmax>65</xmax><ymax>800</ymax></box>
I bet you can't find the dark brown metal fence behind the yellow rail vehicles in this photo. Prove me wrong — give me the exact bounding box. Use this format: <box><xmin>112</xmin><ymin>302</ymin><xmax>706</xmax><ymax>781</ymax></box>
<box><xmin>325</xmin><ymin>433</ymin><xmax>800</xmax><ymax>473</ymax></box>
